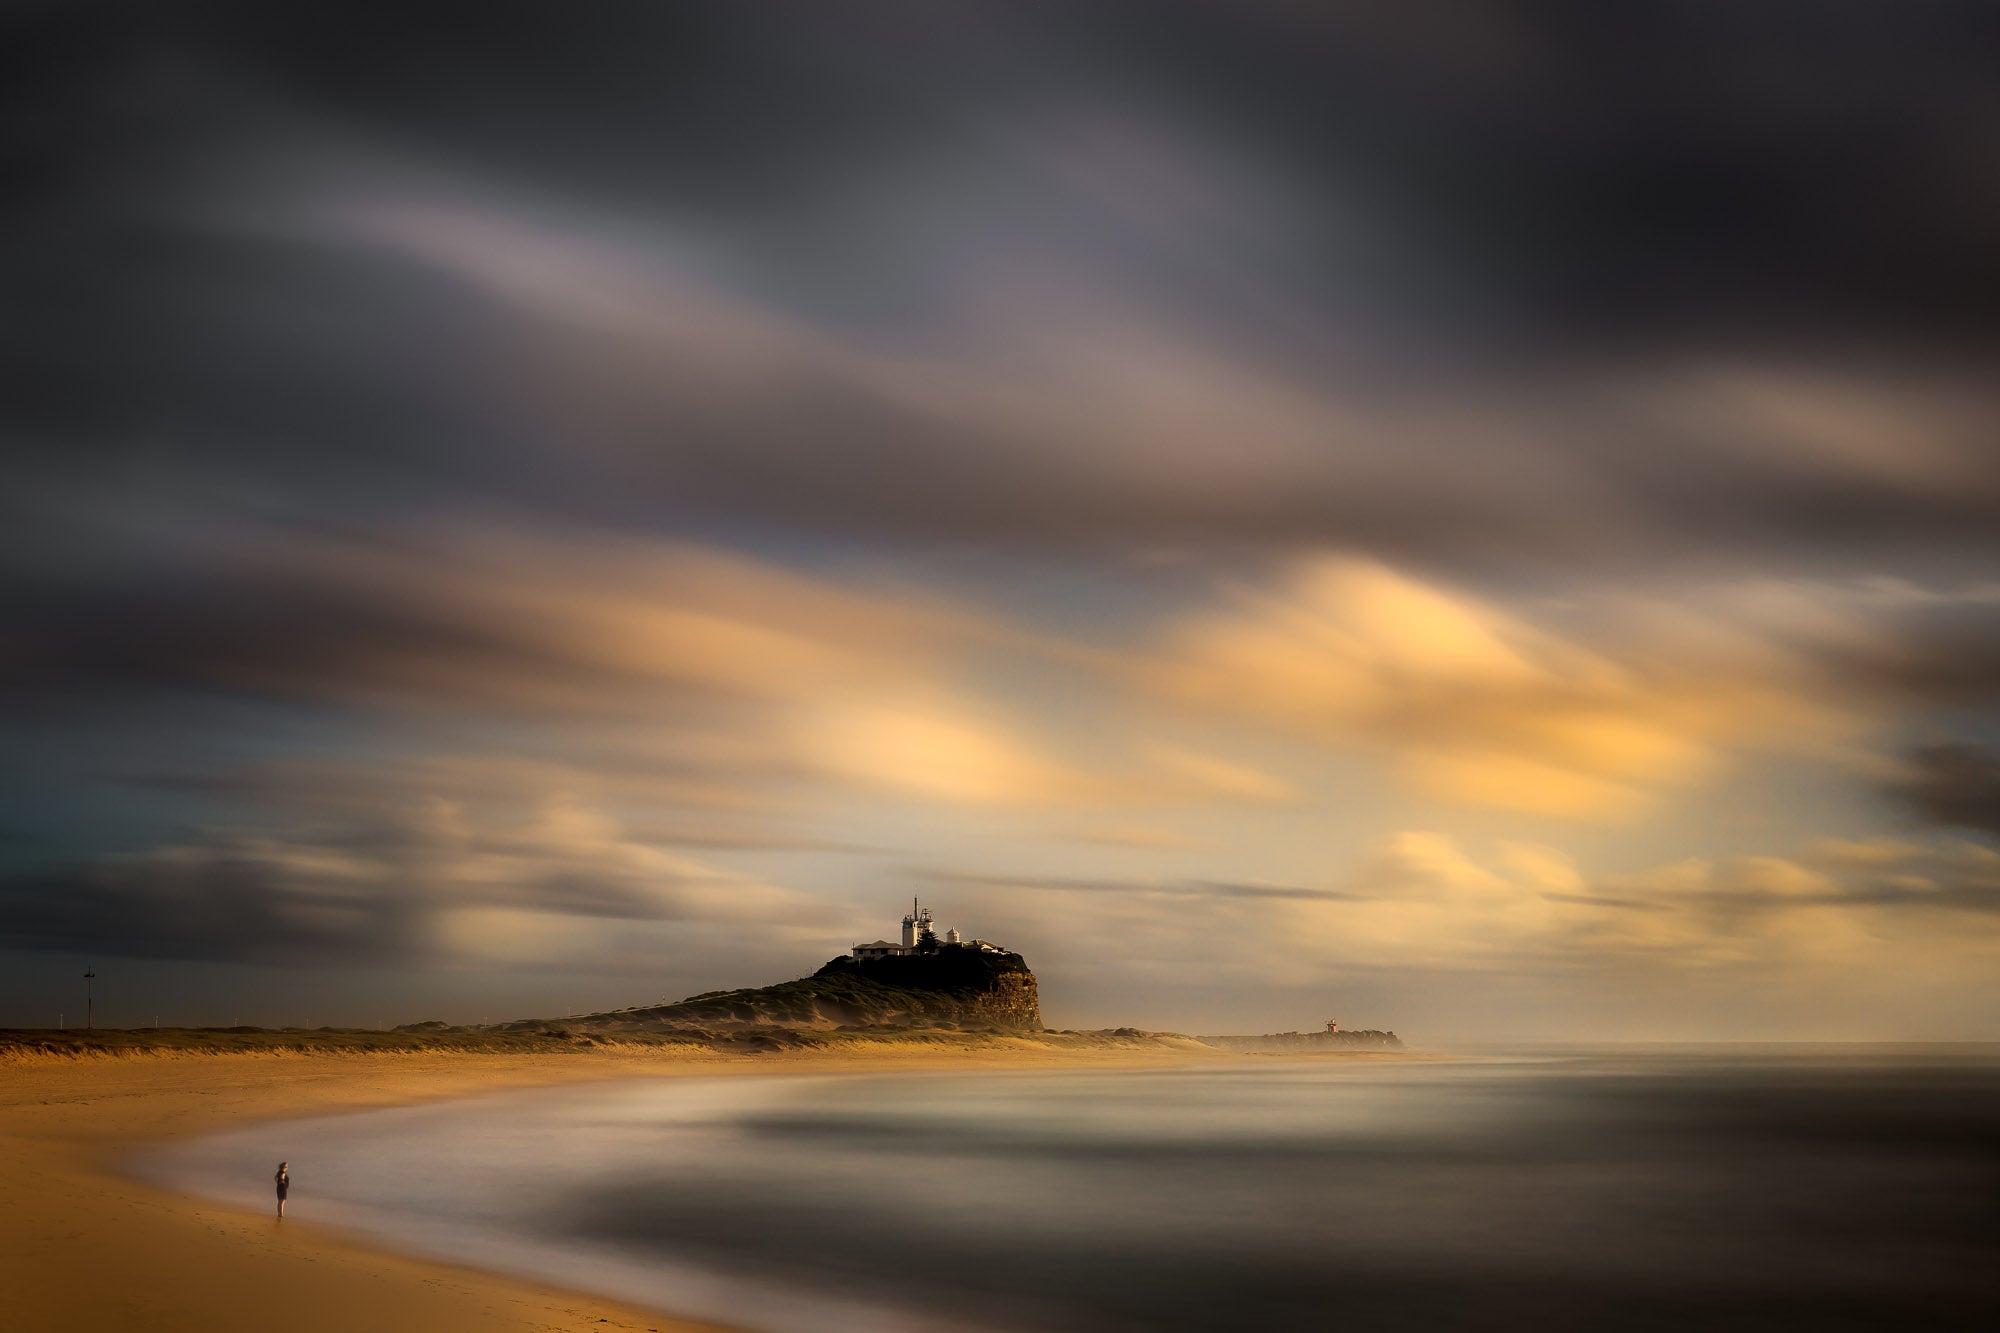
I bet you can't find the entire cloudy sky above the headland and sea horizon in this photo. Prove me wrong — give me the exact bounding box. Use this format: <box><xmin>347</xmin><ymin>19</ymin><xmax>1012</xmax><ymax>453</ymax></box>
<box><xmin>0</xmin><ymin>0</ymin><xmax>2000</xmax><ymax>1041</ymax></box>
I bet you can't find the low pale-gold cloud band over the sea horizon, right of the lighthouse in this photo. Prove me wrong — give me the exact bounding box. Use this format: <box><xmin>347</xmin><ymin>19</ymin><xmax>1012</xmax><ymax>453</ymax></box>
<box><xmin>920</xmin><ymin>831</ymin><xmax>2000</xmax><ymax>1037</ymax></box>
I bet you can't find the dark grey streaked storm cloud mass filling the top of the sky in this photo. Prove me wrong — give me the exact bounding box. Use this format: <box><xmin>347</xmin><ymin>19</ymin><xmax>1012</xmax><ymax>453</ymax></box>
<box><xmin>0</xmin><ymin>2</ymin><xmax>2000</xmax><ymax>562</ymax></box>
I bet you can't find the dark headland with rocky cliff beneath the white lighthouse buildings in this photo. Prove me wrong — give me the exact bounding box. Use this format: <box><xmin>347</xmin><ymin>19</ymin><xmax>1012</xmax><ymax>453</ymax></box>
<box><xmin>600</xmin><ymin>949</ymin><xmax>1042</xmax><ymax>1031</ymax></box>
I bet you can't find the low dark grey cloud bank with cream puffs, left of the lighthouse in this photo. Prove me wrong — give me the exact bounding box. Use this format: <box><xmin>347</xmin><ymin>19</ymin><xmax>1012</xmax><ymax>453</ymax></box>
<box><xmin>0</xmin><ymin>795</ymin><xmax>828</xmax><ymax>963</ymax></box>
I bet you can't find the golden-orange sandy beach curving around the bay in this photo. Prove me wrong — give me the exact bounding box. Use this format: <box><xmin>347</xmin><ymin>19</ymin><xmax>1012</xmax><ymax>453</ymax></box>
<box><xmin>0</xmin><ymin>1043</ymin><xmax>1224</xmax><ymax>1333</ymax></box>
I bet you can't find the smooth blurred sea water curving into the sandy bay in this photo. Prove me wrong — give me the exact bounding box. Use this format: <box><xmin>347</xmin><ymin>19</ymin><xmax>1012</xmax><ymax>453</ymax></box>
<box><xmin>140</xmin><ymin>1049</ymin><xmax>2000</xmax><ymax>1333</ymax></box>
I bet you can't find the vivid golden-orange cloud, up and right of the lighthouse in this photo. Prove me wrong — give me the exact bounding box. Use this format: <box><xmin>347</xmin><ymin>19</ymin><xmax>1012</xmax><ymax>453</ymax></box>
<box><xmin>1132</xmin><ymin>556</ymin><xmax>1846</xmax><ymax>821</ymax></box>
